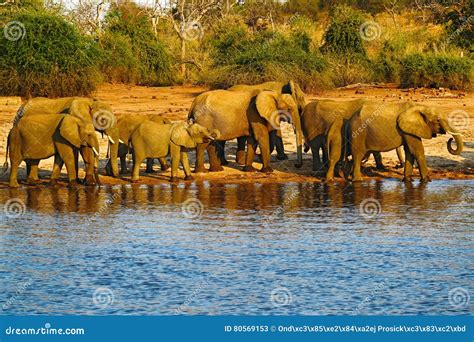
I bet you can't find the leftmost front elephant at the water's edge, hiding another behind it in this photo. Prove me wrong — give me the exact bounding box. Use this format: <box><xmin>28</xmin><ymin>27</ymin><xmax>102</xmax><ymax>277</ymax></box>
<box><xmin>5</xmin><ymin>114</ymin><xmax>99</xmax><ymax>187</ymax></box>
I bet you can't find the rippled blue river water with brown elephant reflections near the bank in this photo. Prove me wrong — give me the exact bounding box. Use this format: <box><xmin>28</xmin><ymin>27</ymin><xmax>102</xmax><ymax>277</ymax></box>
<box><xmin>0</xmin><ymin>180</ymin><xmax>474</xmax><ymax>315</ymax></box>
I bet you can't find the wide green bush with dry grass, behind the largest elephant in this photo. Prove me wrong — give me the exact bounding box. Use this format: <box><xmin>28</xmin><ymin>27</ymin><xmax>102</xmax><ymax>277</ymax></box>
<box><xmin>207</xmin><ymin>27</ymin><xmax>326</xmax><ymax>89</ymax></box>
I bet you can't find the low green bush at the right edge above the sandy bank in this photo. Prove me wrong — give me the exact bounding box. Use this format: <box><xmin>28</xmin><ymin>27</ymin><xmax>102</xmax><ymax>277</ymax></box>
<box><xmin>400</xmin><ymin>54</ymin><xmax>472</xmax><ymax>89</ymax></box>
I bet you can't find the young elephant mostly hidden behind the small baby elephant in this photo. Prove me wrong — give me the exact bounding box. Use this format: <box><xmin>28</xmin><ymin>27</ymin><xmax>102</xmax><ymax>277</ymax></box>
<box><xmin>106</xmin><ymin>114</ymin><xmax>171</xmax><ymax>174</ymax></box>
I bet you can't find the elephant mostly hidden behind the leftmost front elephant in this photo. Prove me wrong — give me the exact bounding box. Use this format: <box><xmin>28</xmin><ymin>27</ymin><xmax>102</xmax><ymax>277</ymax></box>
<box><xmin>14</xmin><ymin>97</ymin><xmax>119</xmax><ymax>185</ymax></box>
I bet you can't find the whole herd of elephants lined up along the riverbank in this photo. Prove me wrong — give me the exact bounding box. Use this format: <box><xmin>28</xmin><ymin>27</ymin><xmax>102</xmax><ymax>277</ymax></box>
<box><xmin>5</xmin><ymin>81</ymin><xmax>463</xmax><ymax>187</ymax></box>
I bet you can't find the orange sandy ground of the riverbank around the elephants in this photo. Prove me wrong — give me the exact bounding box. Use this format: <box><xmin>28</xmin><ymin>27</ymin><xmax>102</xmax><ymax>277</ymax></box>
<box><xmin>0</xmin><ymin>84</ymin><xmax>474</xmax><ymax>187</ymax></box>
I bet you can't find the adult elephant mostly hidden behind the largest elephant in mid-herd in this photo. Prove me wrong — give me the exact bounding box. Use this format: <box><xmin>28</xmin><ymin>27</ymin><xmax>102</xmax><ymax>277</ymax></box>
<box><xmin>217</xmin><ymin>81</ymin><xmax>306</xmax><ymax>165</ymax></box>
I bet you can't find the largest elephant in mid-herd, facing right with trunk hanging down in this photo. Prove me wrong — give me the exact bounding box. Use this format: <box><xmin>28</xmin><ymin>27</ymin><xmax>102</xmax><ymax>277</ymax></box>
<box><xmin>188</xmin><ymin>90</ymin><xmax>303</xmax><ymax>172</ymax></box>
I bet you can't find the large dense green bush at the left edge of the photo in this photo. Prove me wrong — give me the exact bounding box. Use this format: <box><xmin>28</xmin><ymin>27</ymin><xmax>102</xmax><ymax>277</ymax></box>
<box><xmin>0</xmin><ymin>9</ymin><xmax>99</xmax><ymax>97</ymax></box>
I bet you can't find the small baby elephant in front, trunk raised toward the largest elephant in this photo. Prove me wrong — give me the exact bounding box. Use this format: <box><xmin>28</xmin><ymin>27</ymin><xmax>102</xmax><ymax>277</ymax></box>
<box><xmin>131</xmin><ymin>120</ymin><xmax>220</xmax><ymax>182</ymax></box>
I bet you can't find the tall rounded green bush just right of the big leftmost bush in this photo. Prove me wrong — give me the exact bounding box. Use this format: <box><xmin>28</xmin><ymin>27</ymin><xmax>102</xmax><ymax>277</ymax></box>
<box><xmin>102</xmin><ymin>3</ymin><xmax>173</xmax><ymax>85</ymax></box>
